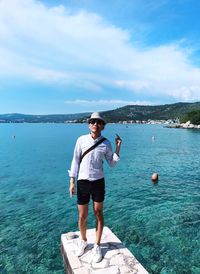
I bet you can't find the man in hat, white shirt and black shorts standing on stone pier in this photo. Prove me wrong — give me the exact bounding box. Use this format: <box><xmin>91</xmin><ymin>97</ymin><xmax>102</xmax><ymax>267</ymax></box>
<box><xmin>69</xmin><ymin>112</ymin><xmax>122</xmax><ymax>263</ymax></box>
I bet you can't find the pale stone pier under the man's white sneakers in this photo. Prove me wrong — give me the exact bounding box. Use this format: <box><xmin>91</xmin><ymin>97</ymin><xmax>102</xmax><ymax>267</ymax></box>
<box><xmin>61</xmin><ymin>227</ymin><xmax>148</xmax><ymax>274</ymax></box>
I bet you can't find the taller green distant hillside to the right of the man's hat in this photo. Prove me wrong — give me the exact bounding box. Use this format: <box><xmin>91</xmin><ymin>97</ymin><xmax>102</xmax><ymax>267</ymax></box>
<box><xmin>99</xmin><ymin>102</ymin><xmax>200</xmax><ymax>122</ymax></box>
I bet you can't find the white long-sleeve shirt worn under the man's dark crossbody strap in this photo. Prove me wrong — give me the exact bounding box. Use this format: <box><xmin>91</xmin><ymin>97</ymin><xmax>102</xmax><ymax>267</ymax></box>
<box><xmin>68</xmin><ymin>134</ymin><xmax>120</xmax><ymax>181</ymax></box>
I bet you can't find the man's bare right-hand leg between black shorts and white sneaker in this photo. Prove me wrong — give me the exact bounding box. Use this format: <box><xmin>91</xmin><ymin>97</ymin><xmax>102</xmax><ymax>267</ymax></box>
<box><xmin>93</xmin><ymin>202</ymin><xmax>104</xmax><ymax>245</ymax></box>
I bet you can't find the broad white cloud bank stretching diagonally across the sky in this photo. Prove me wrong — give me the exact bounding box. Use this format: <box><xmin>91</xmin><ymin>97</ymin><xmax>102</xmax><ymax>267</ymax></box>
<box><xmin>0</xmin><ymin>0</ymin><xmax>200</xmax><ymax>104</ymax></box>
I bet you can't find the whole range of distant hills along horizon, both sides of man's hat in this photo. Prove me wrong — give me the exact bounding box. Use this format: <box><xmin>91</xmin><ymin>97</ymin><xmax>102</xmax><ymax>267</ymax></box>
<box><xmin>0</xmin><ymin>102</ymin><xmax>200</xmax><ymax>123</ymax></box>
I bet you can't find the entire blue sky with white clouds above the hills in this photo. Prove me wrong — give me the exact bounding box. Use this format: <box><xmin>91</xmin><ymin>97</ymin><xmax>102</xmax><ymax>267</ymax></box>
<box><xmin>0</xmin><ymin>0</ymin><xmax>200</xmax><ymax>114</ymax></box>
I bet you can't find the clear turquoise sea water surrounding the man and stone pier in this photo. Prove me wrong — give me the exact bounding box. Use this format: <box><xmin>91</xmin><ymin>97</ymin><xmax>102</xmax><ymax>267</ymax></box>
<box><xmin>0</xmin><ymin>124</ymin><xmax>200</xmax><ymax>274</ymax></box>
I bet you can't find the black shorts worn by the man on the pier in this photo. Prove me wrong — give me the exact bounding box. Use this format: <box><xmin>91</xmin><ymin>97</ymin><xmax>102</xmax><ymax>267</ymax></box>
<box><xmin>77</xmin><ymin>178</ymin><xmax>105</xmax><ymax>205</ymax></box>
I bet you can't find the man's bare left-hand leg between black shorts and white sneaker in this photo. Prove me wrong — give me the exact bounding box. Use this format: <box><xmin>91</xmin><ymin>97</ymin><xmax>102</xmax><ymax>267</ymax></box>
<box><xmin>78</xmin><ymin>205</ymin><xmax>88</xmax><ymax>241</ymax></box>
